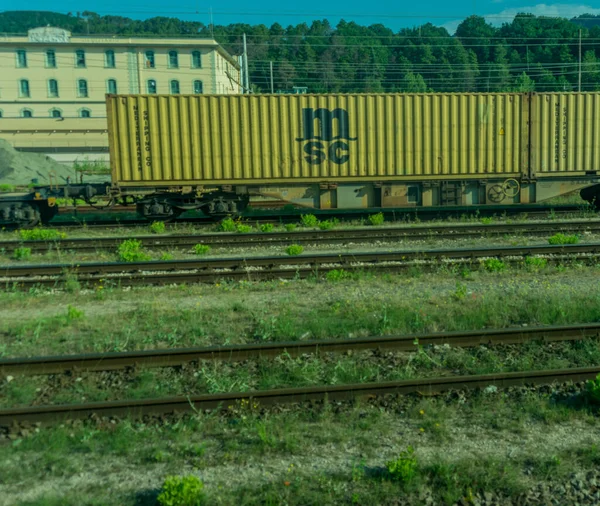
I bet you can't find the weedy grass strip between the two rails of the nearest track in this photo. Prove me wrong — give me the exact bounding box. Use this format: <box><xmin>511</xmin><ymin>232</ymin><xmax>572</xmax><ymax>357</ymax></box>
<box><xmin>0</xmin><ymin>339</ymin><xmax>600</xmax><ymax>407</ymax></box>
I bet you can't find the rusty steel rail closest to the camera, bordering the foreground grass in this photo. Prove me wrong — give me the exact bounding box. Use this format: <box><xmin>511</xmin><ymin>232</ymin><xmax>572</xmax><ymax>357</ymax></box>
<box><xmin>0</xmin><ymin>366</ymin><xmax>600</xmax><ymax>427</ymax></box>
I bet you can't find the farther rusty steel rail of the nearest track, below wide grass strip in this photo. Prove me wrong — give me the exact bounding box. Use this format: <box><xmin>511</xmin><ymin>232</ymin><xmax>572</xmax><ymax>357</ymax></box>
<box><xmin>0</xmin><ymin>323</ymin><xmax>600</xmax><ymax>376</ymax></box>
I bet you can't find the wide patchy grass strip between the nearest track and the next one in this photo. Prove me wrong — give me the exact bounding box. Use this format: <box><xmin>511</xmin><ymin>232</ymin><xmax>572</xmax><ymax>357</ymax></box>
<box><xmin>0</xmin><ymin>267</ymin><xmax>600</xmax><ymax>356</ymax></box>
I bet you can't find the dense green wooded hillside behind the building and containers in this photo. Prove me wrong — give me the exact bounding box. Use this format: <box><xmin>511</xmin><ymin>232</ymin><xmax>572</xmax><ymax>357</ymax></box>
<box><xmin>0</xmin><ymin>11</ymin><xmax>600</xmax><ymax>93</ymax></box>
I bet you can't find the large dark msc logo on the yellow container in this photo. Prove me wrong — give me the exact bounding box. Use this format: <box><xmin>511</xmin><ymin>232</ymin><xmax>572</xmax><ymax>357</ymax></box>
<box><xmin>296</xmin><ymin>108</ymin><xmax>356</xmax><ymax>165</ymax></box>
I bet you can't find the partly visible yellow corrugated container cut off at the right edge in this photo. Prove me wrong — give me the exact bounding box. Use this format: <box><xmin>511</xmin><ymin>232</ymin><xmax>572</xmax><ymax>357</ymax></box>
<box><xmin>530</xmin><ymin>93</ymin><xmax>600</xmax><ymax>177</ymax></box>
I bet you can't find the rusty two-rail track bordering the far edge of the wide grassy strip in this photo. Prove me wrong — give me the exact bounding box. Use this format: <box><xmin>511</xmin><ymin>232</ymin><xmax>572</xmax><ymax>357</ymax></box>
<box><xmin>0</xmin><ymin>243</ymin><xmax>600</xmax><ymax>289</ymax></box>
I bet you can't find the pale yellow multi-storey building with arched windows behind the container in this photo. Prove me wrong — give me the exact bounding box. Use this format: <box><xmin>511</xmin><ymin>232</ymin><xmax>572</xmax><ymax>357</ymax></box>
<box><xmin>0</xmin><ymin>27</ymin><xmax>241</xmax><ymax>119</ymax></box>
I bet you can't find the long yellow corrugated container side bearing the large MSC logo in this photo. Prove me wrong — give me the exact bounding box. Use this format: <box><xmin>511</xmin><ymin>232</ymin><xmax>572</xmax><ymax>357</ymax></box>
<box><xmin>107</xmin><ymin>94</ymin><xmax>529</xmax><ymax>186</ymax></box>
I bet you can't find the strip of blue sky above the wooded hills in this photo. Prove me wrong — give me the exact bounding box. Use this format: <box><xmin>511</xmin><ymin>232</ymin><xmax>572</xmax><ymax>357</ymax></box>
<box><xmin>0</xmin><ymin>0</ymin><xmax>600</xmax><ymax>33</ymax></box>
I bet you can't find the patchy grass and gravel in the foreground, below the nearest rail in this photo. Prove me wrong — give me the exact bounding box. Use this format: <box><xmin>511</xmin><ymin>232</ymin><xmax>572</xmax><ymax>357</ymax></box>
<box><xmin>0</xmin><ymin>386</ymin><xmax>600</xmax><ymax>505</ymax></box>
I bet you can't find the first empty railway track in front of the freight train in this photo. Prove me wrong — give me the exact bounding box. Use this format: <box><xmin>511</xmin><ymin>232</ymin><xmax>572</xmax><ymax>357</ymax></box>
<box><xmin>0</xmin><ymin>220</ymin><xmax>600</xmax><ymax>253</ymax></box>
